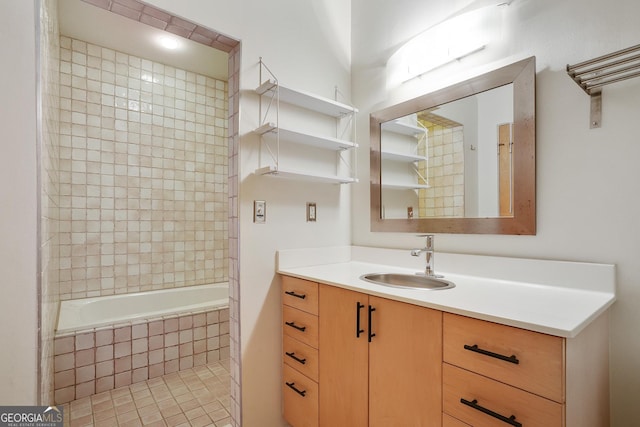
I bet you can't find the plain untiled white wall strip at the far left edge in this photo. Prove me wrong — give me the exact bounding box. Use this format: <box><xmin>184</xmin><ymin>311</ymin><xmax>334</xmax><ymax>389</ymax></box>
<box><xmin>0</xmin><ymin>0</ymin><xmax>38</xmax><ymax>405</ymax></box>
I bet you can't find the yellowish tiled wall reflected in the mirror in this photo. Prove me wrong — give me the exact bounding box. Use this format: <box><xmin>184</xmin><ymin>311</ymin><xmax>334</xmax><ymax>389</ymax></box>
<box><xmin>418</xmin><ymin>122</ymin><xmax>464</xmax><ymax>218</ymax></box>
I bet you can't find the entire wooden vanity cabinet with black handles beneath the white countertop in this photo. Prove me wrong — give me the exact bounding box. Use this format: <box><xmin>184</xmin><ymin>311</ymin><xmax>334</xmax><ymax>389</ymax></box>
<box><xmin>282</xmin><ymin>276</ymin><xmax>609</xmax><ymax>427</ymax></box>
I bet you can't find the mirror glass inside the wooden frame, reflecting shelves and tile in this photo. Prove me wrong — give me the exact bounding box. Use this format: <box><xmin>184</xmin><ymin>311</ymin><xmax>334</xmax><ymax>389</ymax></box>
<box><xmin>380</xmin><ymin>84</ymin><xmax>515</xmax><ymax>219</ymax></box>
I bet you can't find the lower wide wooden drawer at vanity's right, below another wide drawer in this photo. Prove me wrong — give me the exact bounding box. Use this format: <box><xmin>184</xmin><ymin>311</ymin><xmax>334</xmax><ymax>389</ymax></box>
<box><xmin>443</xmin><ymin>363</ymin><xmax>564</xmax><ymax>427</ymax></box>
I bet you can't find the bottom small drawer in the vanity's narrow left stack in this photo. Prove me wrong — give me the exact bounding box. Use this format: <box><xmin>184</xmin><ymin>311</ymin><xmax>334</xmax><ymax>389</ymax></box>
<box><xmin>282</xmin><ymin>365</ymin><xmax>318</xmax><ymax>427</ymax></box>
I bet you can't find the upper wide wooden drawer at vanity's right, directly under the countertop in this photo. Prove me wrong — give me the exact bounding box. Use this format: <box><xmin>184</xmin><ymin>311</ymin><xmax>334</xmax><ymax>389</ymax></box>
<box><xmin>443</xmin><ymin>313</ymin><xmax>565</xmax><ymax>403</ymax></box>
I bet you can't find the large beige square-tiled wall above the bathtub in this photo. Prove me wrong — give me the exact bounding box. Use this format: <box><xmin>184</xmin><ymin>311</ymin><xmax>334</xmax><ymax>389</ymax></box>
<box><xmin>60</xmin><ymin>36</ymin><xmax>228</xmax><ymax>299</ymax></box>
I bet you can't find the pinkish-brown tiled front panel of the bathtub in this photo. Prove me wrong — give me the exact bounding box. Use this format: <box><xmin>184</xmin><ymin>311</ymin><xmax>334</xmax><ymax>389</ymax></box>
<box><xmin>54</xmin><ymin>308</ymin><xmax>229</xmax><ymax>404</ymax></box>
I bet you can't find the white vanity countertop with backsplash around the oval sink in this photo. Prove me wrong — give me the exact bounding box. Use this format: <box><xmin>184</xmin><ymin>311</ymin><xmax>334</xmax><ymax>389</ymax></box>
<box><xmin>277</xmin><ymin>247</ymin><xmax>615</xmax><ymax>338</ymax></box>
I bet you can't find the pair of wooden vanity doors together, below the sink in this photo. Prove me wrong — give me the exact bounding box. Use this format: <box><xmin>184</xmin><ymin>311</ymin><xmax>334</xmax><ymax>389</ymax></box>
<box><xmin>318</xmin><ymin>284</ymin><xmax>442</xmax><ymax>427</ymax></box>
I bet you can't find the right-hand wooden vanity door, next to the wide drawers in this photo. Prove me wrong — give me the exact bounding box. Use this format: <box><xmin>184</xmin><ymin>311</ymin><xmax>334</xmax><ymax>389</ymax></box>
<box><xmin>369</xmin><ymin>296</ymin><xmax>442</xmax><ymax>427</ymax></box>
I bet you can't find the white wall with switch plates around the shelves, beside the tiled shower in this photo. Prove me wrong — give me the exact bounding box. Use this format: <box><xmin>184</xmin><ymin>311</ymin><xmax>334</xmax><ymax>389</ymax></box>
<box><xmin>150</xmin><ymin>0</ymin><xmax>351</xmax><ymax>427</ymax></box>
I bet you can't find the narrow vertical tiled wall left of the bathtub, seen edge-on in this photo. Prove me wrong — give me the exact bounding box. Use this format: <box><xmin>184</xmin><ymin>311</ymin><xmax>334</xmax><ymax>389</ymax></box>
<box><xmin>38</xmin><ymin>1</ymin><xmax>60</xmax><ymax>405</ymax></box>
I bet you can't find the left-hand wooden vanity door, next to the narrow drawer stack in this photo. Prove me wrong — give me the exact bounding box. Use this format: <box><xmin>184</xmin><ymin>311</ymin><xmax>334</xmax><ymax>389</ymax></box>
<box><xmin>318</xmin><ymin>285</ymin><xmax>369</xmax><ymax>427</ymax></box>
